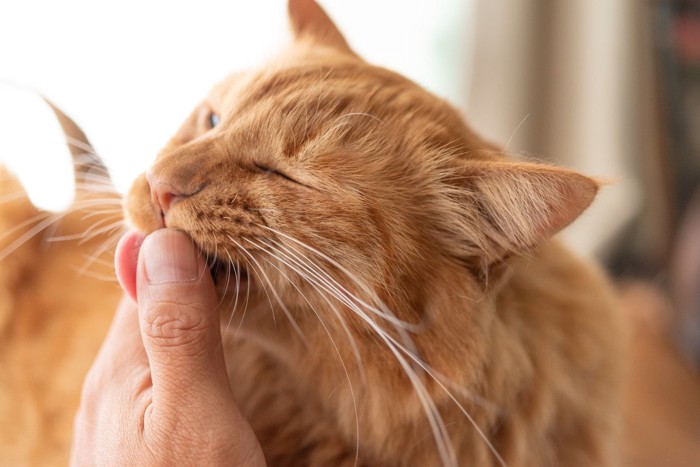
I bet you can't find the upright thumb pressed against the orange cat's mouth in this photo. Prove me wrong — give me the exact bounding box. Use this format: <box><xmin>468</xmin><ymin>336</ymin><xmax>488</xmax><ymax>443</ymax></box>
<box><xmin>136</xmin><ymin>229</ymin><xmax>230</xmax><ymax>409</ymax></box>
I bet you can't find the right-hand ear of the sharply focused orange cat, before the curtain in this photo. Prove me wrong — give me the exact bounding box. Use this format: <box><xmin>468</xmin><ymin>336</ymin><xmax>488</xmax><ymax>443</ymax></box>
<box><xmin>460</xmin><ymin>161</ymin><xmax>599</xmax><ymax>263</ymax></box>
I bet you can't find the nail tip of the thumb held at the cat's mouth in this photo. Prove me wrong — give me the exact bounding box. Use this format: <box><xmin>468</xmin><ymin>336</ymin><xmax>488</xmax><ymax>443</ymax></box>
<box><xmin>141</xmin><ymin>229</ymin><xmax>199</xmax><ymax>284</ymax></box>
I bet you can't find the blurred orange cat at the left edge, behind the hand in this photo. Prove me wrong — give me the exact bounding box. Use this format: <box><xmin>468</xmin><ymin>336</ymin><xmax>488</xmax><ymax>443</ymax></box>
<box><xmin>0</xmin><ymin>102</ymin><xmax>124</xmax><ymax>466</ymax></box>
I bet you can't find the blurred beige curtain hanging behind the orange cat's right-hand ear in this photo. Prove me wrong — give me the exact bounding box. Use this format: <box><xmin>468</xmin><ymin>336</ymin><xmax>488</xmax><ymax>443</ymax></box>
<box><xmin>466</xmin><ymin>0</ymin><xmax>665</xmax><ymax>260</ymax></box>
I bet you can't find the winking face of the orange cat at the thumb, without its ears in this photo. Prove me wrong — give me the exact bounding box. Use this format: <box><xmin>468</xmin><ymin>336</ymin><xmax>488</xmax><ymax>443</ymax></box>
<box><xmin>127</xmin><ymin>44</ymin><xmax>454</xmax><ymax>310</ymax></box>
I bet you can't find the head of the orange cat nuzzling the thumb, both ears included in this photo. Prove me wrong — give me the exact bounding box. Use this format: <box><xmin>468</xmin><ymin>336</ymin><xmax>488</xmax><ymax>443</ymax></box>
<box><xmin>126</xmin><ymin>0</ymin><xmax>597</xmax><ymax>318</ymax></box>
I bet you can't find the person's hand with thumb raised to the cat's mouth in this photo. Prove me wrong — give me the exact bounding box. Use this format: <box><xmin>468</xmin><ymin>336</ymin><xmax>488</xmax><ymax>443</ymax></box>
<box><xmin>71</xmin><ymin>229</ymin><xmax>265</xmax><ymax>466</ymax></box>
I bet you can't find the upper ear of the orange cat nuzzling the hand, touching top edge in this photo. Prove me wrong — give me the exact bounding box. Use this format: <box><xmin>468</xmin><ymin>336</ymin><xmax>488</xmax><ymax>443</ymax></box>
<box><xmin>289</xmin><ymin>0</ymin><xmax>354</xmax><ymax>54</ymax></box>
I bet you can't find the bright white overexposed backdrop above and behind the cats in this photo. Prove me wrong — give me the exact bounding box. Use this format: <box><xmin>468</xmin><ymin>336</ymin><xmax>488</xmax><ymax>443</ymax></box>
<box><xmin>0</xmin><ymin>0</ymin><xmax>472</xmax><ymax>209</ymax></box>
